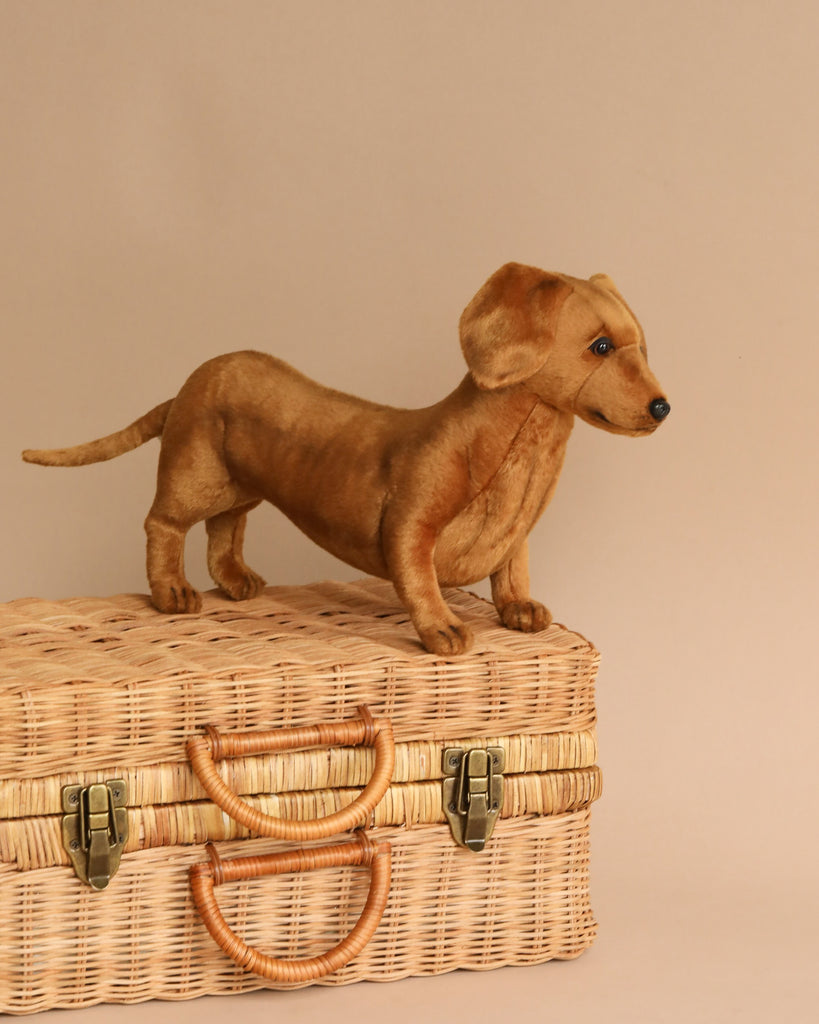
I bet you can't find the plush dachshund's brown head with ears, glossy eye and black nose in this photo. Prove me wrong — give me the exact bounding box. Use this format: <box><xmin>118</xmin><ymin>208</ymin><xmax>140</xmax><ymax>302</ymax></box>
<box><xmin>461</xmin><ymin>263</ymin><xmax>671</xmax><ymax>436</ymax></box>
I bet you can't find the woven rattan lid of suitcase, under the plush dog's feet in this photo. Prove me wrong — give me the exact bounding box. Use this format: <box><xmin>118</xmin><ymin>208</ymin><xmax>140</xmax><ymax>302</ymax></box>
<box><xmin>0</xmin><ymin>580</ymin><xmax>599</xmax><ymax>778</ymax></box>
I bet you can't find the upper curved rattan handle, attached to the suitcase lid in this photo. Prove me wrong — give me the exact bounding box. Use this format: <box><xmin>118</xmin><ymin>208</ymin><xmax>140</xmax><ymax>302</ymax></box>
<box><xmin>186</xmin><ymin>707</ymin><xmax>395</xmax><ymax>843</ymax></box>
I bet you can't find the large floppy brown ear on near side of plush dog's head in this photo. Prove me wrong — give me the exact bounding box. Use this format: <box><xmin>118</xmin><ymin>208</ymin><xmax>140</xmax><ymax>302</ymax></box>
<box><xmin>460</xmin><ymin>263</ymin><xmax>571</xmax><ymax>389</ymax></box>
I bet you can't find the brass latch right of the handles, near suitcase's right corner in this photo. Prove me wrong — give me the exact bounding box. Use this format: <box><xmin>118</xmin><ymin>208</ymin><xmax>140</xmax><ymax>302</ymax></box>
<box><xmin>443</xmin><ymin>746</ymin><xmax>506</xmax><ymax>851</ymax></box>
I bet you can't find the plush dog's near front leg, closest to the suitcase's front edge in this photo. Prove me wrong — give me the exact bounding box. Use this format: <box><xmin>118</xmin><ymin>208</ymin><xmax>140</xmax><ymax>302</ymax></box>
<box><xmin>382</xmin><ymin>522</ymin><xmax>472</xmax><ymax>655</ymax></box>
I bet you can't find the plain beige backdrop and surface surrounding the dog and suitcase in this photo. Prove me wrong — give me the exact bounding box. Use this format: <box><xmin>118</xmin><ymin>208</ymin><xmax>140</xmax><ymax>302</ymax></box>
<box><xmin>0</xmin><ymin>0</ymin><xmax>819</xmax><ymax>1024</ymax></box>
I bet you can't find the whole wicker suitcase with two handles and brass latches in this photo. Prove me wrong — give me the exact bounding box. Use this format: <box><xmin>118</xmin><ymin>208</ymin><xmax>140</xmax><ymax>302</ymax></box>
<box><xmin>0</xmin><ymin>581</ymin><xmax>601</xmax><ymax>1013</ymax></box>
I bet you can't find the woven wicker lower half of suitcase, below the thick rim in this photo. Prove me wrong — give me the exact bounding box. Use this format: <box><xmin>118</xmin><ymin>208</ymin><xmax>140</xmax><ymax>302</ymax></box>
<box><xmin>0</xmin><ymin>810</ymin><xmax>595</xmax><ymax>1013</ymax></box>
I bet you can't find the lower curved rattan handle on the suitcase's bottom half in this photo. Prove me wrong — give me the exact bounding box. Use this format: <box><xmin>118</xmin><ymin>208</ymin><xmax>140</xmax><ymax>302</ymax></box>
<box><xmin>190</xmin><ymin>833</ymin><xmax>391</xmax><ymax>984</ymax></box>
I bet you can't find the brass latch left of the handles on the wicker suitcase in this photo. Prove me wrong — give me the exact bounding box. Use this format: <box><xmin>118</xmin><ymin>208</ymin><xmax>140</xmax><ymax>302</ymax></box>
<box><xmin>62</xmin><ymin>778</ymin><xmax>128</xmax><ymax>889</ymax></box>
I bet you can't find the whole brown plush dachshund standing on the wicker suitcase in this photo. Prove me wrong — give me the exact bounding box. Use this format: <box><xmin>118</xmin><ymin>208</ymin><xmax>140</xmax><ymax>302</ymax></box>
<box><xmin>23</xmin><ymin>263</ymin><xmax>671</xmax><ymax>655</ymax></box>
